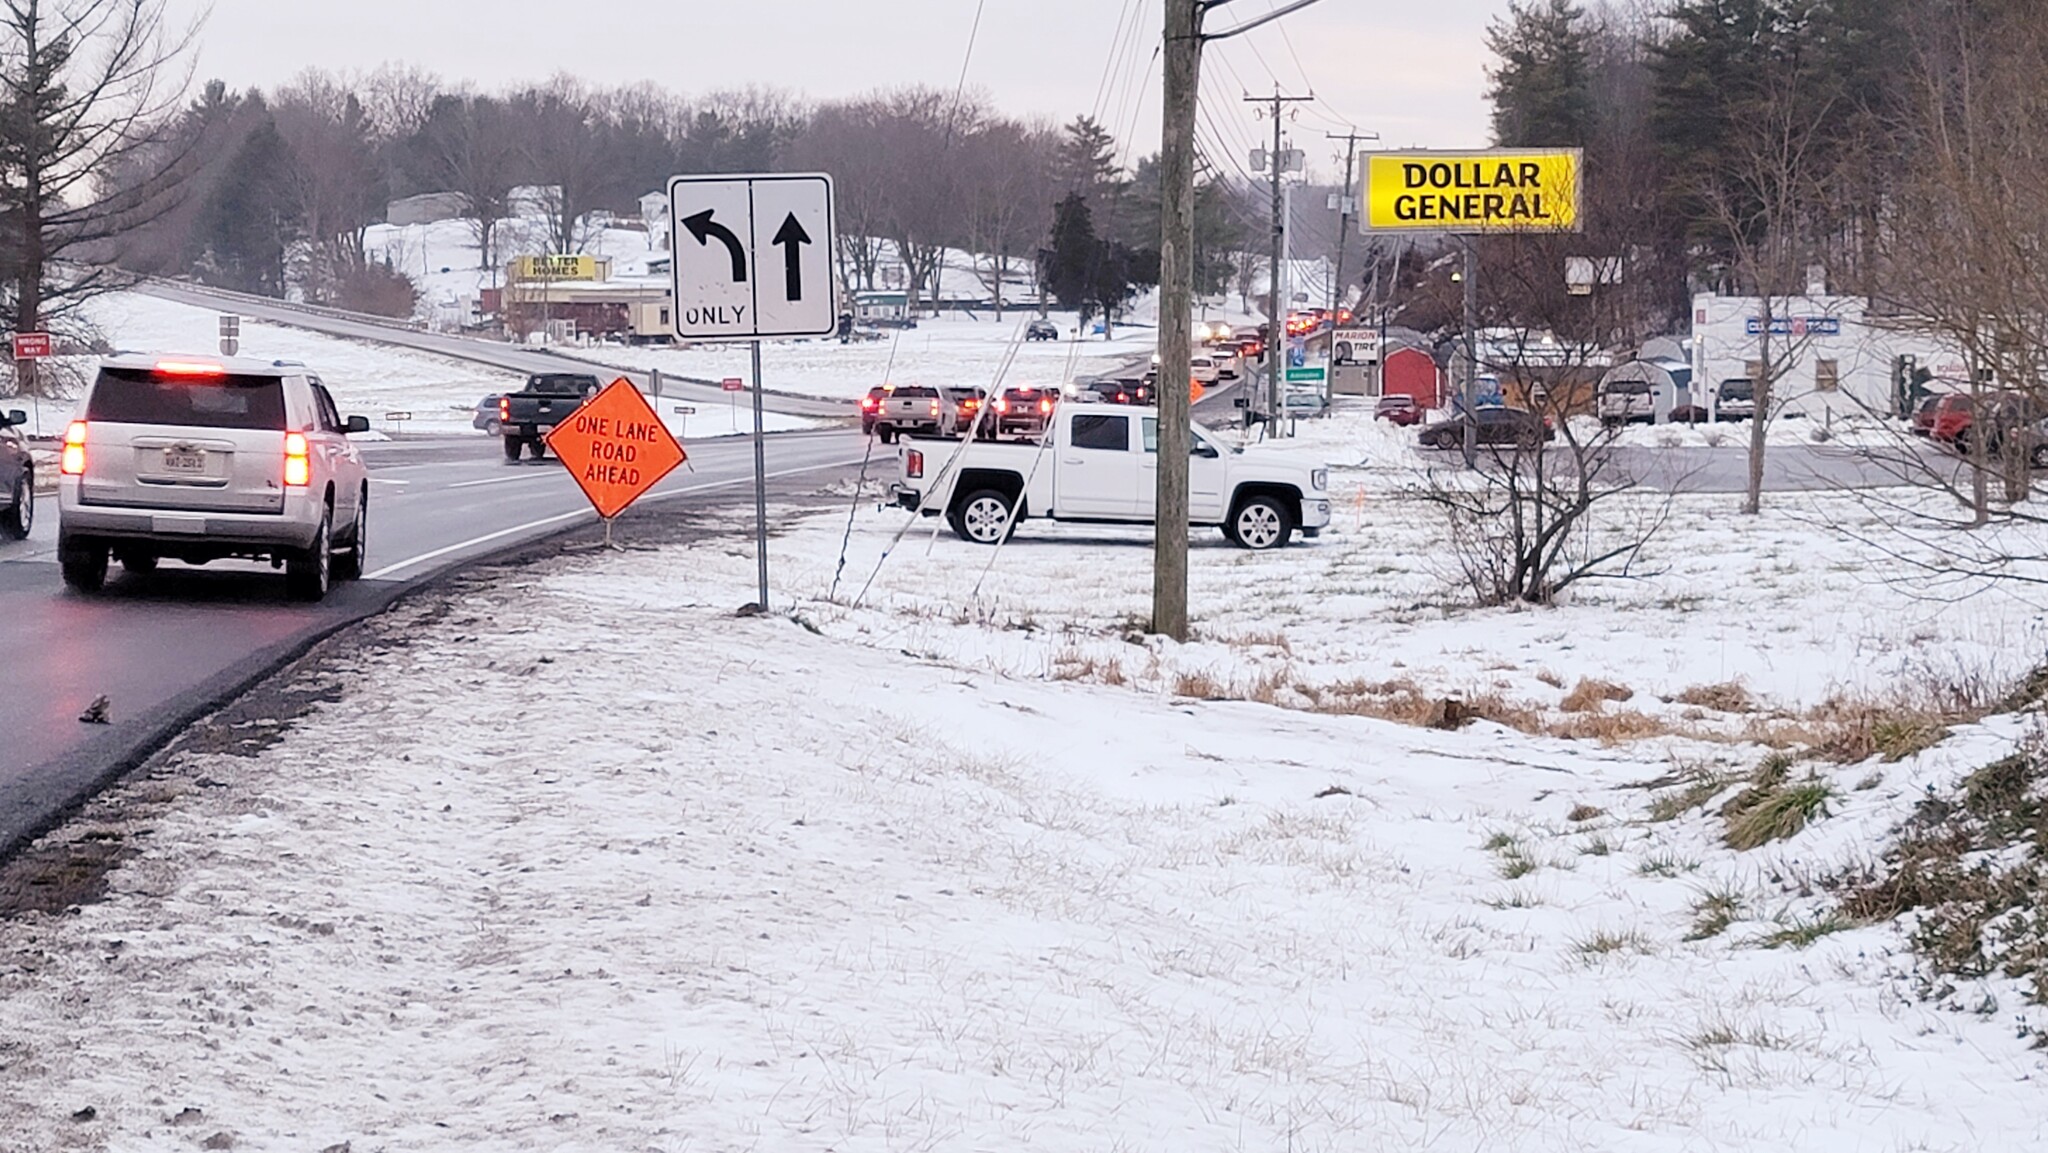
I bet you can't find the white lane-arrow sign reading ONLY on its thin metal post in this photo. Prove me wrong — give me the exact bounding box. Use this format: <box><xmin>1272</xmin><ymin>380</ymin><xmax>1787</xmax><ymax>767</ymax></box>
<box><xmin>668</xmin><ymin>172</ymin><xmax>840</xmax><ymax>610</ymax></box>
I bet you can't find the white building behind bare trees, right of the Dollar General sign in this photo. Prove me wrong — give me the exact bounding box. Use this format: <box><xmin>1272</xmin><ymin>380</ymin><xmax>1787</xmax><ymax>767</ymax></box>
<box><xmin>1692</xmin><ymin>293</ymin><xmax>1970</xmax><ymax>416</ymax></box>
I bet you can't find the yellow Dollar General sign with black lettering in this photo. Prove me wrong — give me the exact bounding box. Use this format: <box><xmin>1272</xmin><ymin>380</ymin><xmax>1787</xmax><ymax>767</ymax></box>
<box><xmin>1364</xmin><ymin>147</ymin><xmax>1579</xmax><ymax>231</ymax></box>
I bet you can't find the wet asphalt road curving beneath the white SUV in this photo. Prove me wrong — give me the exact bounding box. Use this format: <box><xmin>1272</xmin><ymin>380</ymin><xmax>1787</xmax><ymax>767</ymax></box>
<box><xmin>0</xmin><ymin>423</ymin><xmax>866</xmax><ymax>858</ymax></box>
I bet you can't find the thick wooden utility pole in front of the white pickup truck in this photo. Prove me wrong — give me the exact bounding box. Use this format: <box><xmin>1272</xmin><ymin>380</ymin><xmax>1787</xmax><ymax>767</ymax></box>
<box><xmin>1151</xmin><ymin>0</ymin><xmax>1317</xmax><ymax>641</ymax></box>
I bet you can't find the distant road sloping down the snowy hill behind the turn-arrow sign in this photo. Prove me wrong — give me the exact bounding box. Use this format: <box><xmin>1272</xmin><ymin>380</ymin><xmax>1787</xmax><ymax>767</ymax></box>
<box><xmin>135</xmin><ymin>281</ymin><xmax>858</xmax><ymax>416</ymax></box>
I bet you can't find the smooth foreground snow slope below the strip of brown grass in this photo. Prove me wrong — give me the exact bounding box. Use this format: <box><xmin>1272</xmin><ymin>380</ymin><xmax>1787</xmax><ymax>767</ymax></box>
<box><xmin>0</xmin><ymin>516</ymin><xmax>2048</xmax><ymax>1153</ymax></box>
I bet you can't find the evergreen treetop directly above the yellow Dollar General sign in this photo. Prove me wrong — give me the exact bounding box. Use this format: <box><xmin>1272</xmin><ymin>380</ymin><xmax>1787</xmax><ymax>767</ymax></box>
<box><xmin>1487</xmin><ymin>0</ymin><xmax>1593</xmax><ymax>147</ymax></box>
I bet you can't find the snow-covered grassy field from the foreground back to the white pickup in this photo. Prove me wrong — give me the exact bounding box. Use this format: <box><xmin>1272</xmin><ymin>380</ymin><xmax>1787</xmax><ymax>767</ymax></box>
<box><xmin>0</xmin><ymin>395</ymin><xmax>2048</xmax><ymax>1153</ymax></box>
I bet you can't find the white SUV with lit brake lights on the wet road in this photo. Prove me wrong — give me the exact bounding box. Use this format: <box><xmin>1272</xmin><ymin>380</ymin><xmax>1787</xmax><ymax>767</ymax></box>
<box><xmin>57</xmin><ymin>352</ymin><xmax>369</xmax><ymax>600</ymax></box>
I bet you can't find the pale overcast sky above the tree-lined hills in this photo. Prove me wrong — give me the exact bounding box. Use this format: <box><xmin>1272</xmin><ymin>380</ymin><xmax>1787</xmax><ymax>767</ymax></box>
<box><xmin>168</xmin><ymin>0</ymin><xmax>1505</xmax><ymax>180</ymax></box>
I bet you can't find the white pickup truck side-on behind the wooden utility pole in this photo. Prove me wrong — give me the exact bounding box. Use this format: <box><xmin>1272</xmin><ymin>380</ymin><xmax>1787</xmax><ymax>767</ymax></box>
<box><xmin>891</xmin><ymin>403</ymin><xmax>1329</xmax><ymax>549</ymax></box>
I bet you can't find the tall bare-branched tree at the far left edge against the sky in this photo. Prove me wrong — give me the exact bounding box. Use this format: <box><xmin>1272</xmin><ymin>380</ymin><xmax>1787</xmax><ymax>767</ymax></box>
<box><xmin>0</xmin><ymin>0</ymin><xmax>193</xmax><ymax>393</ymax></box>
